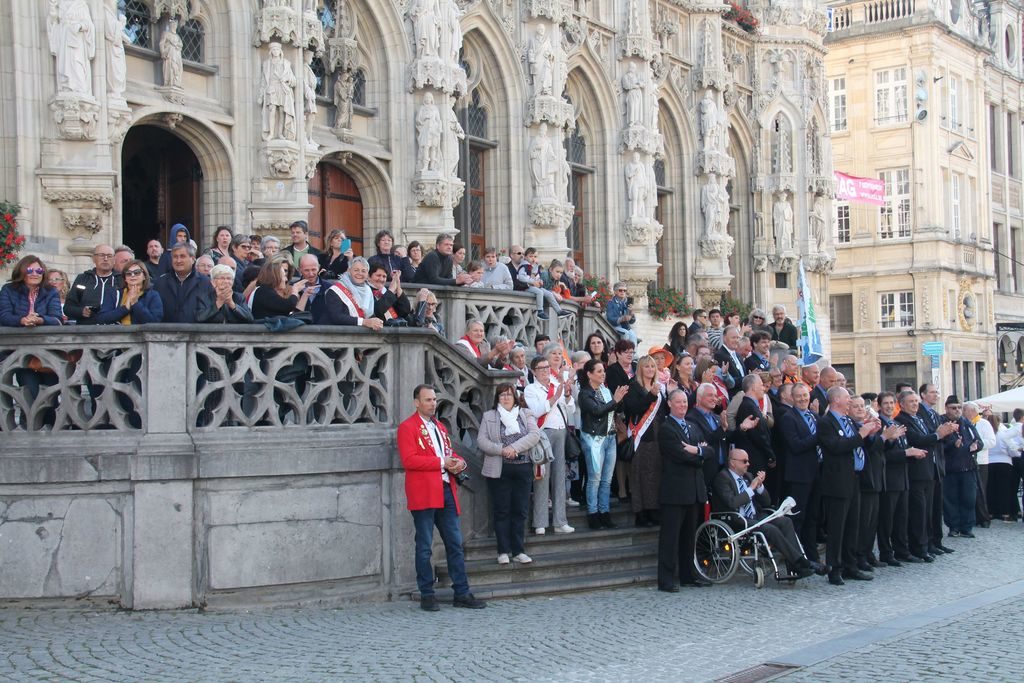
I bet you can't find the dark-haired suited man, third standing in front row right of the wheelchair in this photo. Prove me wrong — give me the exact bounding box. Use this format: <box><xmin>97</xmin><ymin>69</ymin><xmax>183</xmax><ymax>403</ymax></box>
<box><xmin>878</xmin><ymin>391</ymin><xmax>928</xmax><ymax>567</ymax></box>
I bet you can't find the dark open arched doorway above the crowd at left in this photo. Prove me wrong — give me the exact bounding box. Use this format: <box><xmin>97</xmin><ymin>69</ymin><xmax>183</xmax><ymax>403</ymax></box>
<box><xmin>121</xmin><ymin>125</ymin><xmax>203</xmax><ymax>253</ymax></box>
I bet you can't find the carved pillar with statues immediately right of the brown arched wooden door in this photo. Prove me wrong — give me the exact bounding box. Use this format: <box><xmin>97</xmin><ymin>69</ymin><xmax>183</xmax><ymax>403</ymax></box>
<box><xmin>404</xmin><ymin>0</ymin><xmax>466</xmax><ymax>245</ymax></box>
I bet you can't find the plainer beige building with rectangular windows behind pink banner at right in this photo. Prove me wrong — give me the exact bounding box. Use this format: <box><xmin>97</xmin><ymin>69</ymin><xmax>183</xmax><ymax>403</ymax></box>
<box><xmin>825</xmin><ymin>0</ymin><xmax>1024</xmax><ymax>399</ymax></box>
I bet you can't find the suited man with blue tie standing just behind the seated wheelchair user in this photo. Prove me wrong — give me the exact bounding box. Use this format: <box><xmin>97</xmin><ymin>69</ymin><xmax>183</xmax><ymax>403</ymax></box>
<box><xmin>775</xmin><ymin>384</ymin><xmax>821</xmax><ymax>560</ymax></box>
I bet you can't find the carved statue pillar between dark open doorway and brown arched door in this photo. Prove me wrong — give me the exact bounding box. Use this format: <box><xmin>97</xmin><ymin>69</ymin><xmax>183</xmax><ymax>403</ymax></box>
<box><xmin>249</xmin><ymin>0</ymin><xmax>325</xmax><ymax>234</ymax></box>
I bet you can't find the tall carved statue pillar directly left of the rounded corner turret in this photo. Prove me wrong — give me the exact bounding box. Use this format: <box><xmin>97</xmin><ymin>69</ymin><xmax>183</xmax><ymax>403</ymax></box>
<box><xmin>692</xmin><ymin>10</ymin><xmax>736</xmax><ymax>306</ymax></box>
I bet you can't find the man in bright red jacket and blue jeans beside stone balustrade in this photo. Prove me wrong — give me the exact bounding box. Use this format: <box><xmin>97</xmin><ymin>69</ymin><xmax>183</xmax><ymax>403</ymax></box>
<box><xmin>398</xmin><ymin>384</ymin><xmax>487</xmax><ymax>612</ymax></box>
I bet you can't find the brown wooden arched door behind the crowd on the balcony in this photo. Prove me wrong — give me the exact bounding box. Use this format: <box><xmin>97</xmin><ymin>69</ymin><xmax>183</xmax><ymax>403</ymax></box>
<box><xmin>309</xmin><ymin>162</ymin><xmax>366</xmax><ymax>256</ymax></box>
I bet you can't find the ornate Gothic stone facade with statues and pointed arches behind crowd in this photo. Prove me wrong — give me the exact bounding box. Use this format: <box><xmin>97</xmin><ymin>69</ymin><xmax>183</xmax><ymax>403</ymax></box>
<box><xmin>0</xmin><ymin>0</ymin><xmax>831</xmax><ymax>314</ymax></box>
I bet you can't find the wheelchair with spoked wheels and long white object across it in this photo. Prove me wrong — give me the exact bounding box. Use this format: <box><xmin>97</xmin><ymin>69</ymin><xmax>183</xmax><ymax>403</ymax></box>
<box><xmin>693</xmin><ymin>498</ymin><xmax>803</xmax><ymax>588</ymax></box>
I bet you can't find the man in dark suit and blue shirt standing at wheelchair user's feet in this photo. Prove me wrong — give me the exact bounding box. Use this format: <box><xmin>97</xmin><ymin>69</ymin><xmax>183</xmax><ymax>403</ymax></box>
<box><xmin>818</xmin><ymin>387</ymin><xmax>881</xmax><ymax>586</ymax></box>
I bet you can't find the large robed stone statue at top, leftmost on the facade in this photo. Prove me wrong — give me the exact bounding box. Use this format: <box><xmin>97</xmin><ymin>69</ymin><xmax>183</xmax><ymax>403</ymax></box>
<box><xmin>46</xmin><ymin>0</ymin><xmax>96</xmax><ymax>97</ymax></box>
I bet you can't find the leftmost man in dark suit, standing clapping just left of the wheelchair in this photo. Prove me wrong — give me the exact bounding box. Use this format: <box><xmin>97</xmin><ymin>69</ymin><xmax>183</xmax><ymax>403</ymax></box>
<box><xmin>657</xmin><ymin>389</ymin><xmax>715</xmax><ymax>593</ymax></box>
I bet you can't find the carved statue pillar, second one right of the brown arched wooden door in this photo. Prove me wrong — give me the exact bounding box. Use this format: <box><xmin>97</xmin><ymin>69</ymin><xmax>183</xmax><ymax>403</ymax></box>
<box><xmin>523</xmin><ymin>0</ymin><xmax>575</xmax><ymax>263</ymax></box>
